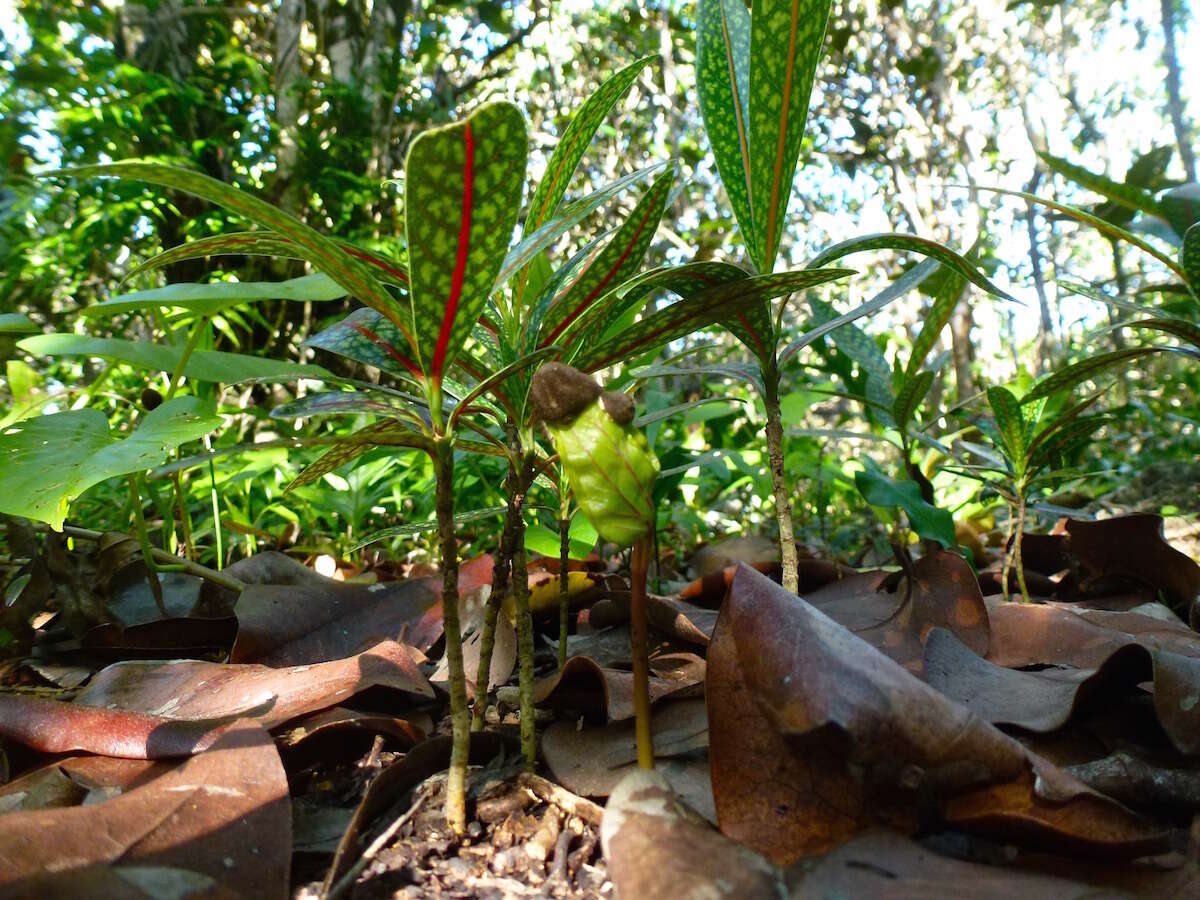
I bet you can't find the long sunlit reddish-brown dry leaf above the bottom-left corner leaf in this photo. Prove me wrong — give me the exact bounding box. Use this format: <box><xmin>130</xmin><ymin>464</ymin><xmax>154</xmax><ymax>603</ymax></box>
<box><xmin>76</xmin><ymin>641</ymin><xmax>433</xmax><ymax>728</ymax></box>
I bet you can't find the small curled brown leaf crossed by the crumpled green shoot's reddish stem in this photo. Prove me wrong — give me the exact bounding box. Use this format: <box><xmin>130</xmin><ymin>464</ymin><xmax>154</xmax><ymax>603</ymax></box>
<box><xmin>534</xmin><ymin>653</ymin><xmax>706</xmax><ymax>722</ymax></box>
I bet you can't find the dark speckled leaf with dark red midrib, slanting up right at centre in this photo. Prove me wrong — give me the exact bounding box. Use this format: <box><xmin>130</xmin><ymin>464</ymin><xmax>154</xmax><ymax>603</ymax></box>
<box><xmin>539</xmin><ymin>167</ymin><xmax>676</xmax><ymax>347</ymax></box>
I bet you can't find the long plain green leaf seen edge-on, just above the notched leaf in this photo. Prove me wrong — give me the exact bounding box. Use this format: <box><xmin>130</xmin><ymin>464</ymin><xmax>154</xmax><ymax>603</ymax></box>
<box><xmin>17</xmin><ymin>334</ymin><xmax>329</xmax><ymax>384</ymax></box>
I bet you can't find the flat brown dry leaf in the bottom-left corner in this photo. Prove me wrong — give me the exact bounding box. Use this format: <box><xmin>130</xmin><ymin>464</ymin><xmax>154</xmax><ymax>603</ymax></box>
<box><xmin>0</xmin><ymin>721</ymin><xmax>292</xmax><ymax>900</ymax></box>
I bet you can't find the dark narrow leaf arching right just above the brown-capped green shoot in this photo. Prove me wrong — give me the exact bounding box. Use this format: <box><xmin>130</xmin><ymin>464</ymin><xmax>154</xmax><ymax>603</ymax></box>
<box><xmin>572</xmin><ymin>269</ymin><xmax>854</xmax><ymax>372</ymax></box>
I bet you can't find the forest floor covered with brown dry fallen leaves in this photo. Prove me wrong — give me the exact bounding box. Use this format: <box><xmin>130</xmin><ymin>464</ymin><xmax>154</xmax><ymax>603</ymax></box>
<box><xmin>0</xmin><ymin>496</ymin><xmax>1200</xmax><ymax>900</ymax></box>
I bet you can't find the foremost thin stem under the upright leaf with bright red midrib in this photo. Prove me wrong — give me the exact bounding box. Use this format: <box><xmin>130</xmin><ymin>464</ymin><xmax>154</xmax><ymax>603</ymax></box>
<box><xmin>433</xmin><ymin>436</ymin><xmax>470</xmax><ymax>834</ymax></box>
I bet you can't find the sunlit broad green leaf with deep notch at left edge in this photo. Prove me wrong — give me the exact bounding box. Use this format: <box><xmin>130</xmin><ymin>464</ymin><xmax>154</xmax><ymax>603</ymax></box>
<box><xmin>0</xmin><ymin>397</ymin><xmax>221</xmax><ymax>532</ymax></box>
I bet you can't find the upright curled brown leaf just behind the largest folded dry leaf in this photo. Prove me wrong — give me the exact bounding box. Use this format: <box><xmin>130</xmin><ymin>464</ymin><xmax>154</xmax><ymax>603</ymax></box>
<box><xmin>806</xmin><ymin>551</ymin><xmax>989</xmax><ymax>674</ymax></box>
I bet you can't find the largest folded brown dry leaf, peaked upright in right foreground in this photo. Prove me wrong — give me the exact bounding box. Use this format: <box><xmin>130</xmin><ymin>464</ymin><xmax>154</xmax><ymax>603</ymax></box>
<box><xmin>708</xmin><ymin>568</ymin><xmax>1163</xmax><ymax>863</ymax></box>
